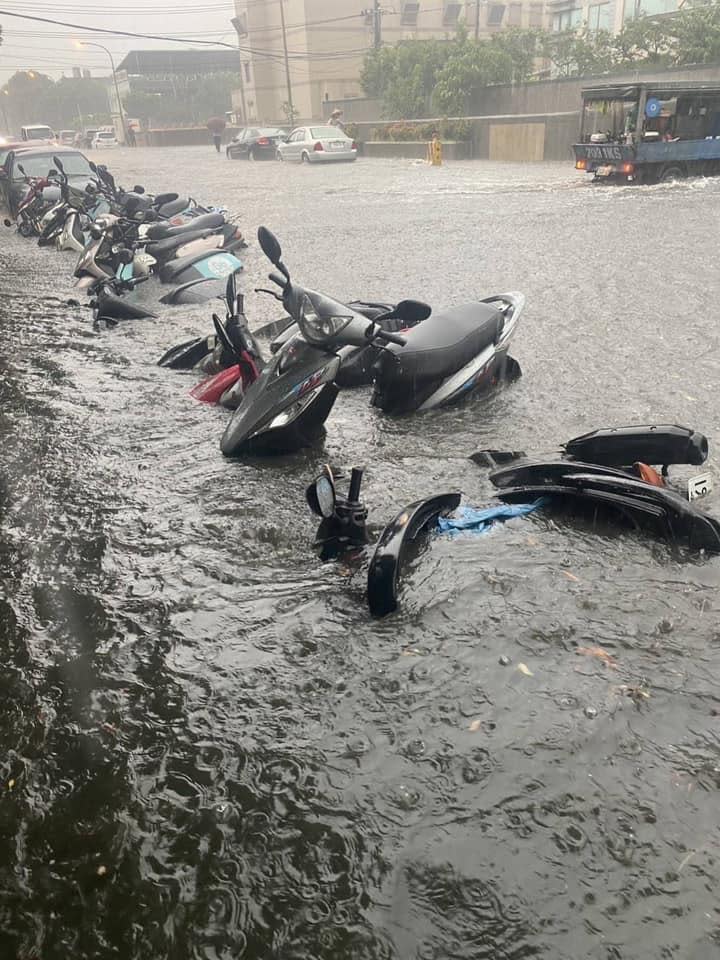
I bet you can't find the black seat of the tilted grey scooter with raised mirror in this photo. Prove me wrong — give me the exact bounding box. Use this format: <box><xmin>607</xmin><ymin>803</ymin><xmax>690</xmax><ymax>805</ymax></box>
<box><xmin>377</xmin><ymin>303</ymin><xmax>505</xmax><ymax>382</ymax></box>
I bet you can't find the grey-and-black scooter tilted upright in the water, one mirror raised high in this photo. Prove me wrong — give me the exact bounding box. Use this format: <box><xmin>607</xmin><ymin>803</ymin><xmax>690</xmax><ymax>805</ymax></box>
<box><xmin>220</xmin><ymin>227</ymin><xmax>525</xmax><ymax>456</ymax></box>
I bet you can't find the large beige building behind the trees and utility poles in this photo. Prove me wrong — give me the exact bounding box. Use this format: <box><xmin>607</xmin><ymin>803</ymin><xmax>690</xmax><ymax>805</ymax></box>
<box><xmin>234</xmin><ymin>0</ymin><xmax>550</xmax><ymax>122</ymax></box>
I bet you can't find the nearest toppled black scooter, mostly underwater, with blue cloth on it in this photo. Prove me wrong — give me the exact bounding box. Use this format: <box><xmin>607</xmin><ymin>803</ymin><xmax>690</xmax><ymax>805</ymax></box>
<box><xmin>306</xmin><ymin>424</ymin><xmax>720</xmax><ymax>616</ymax></box>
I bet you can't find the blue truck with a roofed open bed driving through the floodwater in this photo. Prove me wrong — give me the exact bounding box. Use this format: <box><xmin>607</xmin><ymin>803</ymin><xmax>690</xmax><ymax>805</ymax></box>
<box><xmin>573</xmin><ymin>81</ymin><xmax>720</xmax><ymax>183</ymax></box>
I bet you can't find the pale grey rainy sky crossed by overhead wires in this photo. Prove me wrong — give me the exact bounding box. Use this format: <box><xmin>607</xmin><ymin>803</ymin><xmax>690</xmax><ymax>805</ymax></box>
<box><xmin>0</xmin><ymin>0</ymin><xmax>237</xmax><ymax>84</ymax></box>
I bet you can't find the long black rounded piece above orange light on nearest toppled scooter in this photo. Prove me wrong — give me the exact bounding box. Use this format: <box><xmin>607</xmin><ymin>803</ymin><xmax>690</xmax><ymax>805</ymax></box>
<box><xmin>565</xmin><ymin>424</ymin><xmax>708</xmax><ymax>467</ymax></box>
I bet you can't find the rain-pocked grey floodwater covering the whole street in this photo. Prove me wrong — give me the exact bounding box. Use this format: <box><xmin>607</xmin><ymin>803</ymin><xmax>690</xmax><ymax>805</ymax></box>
<box><xmin>0</xmin><ymin>147</ymin><xmax>720</xmax><ymax>960</ymax></box>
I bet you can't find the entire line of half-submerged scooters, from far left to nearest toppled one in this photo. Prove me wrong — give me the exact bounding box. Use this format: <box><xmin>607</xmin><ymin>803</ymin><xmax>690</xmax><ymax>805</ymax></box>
<box><xmin>6</xmin><ymin>157</ymin><xmax>720</xmax><ymax>614</ymax></box>
